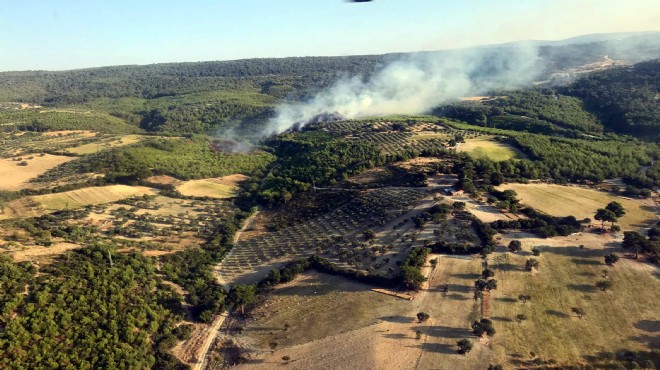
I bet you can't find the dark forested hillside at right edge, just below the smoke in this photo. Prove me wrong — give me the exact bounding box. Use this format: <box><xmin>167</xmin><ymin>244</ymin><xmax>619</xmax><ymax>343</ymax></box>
<box><xmin>435</xmin><ymin>60</ymin><xmax>660</xmax><ymax>140</ymax></box>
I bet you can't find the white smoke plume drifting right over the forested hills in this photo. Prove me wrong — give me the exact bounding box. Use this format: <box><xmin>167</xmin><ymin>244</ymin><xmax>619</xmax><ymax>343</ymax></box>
<box><xmin>264</xmin><ymin>45</ymin><xmax>541</xmax><ymax>136</ymax></box>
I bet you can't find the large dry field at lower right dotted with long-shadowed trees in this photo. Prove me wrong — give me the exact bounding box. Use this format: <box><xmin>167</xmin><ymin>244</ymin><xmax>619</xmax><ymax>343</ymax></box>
<box><xmin>489</xmin><ymin>233</ymin><xmax>660</xmax><ymax>367</ymax></box>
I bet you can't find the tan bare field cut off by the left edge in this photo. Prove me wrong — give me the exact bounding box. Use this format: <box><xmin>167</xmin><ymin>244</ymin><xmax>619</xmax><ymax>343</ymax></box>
<box><xmin>0</xmin><ymin>154</ymin><xmax>75</xmax><ymax>191</ymax></box>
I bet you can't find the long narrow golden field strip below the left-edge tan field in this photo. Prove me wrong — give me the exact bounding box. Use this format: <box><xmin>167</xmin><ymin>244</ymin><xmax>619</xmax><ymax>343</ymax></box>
<box><xmin>30</xmin><ymin>185</ymin><xmax>155</xmax><ymax>211</ymax></box>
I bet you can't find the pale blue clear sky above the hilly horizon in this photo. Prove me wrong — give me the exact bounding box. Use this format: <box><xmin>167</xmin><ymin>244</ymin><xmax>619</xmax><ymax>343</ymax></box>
<box><xmin>0</xmin><ymin>0</ymin><xmax>660</xmax><ymax>71</ymax></box>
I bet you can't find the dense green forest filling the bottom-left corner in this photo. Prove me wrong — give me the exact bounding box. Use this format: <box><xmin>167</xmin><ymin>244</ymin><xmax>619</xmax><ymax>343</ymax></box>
<box><xmin>0</xmin><ymin>245</ymin><xmax>191</xmax><ymax>369</ymax></box>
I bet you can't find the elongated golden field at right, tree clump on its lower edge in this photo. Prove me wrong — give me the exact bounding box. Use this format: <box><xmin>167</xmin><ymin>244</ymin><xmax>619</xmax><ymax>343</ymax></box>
<box><xmin>499</xmin><ymin>184</ymin><xmax>657</xmax><ymax>230</ymax></box>
